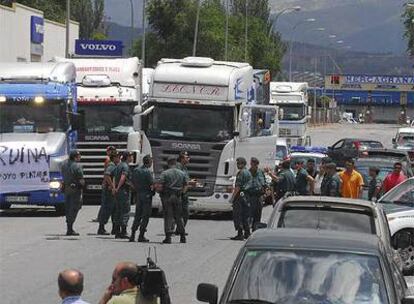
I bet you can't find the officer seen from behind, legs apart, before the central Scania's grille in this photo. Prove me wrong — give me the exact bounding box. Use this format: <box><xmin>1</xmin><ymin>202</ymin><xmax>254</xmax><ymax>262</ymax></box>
<box><xmin>157</xmin><ymin>156</ymin><xmax>187</xmax><ymax>244</ymax></box>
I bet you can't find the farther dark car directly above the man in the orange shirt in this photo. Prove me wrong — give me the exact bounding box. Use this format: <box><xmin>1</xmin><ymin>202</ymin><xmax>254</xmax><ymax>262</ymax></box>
<box><xmin>328</xmin><ymin>138</ymin><xmax>384</xmax><ymax>167</ymax></box>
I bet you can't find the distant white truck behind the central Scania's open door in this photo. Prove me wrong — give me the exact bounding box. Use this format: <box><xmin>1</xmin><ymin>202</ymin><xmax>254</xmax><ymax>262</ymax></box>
<box><xmin>269</xmin><ymin>82</ymin><xmax>310</xmax><ymax>146</ymax></box>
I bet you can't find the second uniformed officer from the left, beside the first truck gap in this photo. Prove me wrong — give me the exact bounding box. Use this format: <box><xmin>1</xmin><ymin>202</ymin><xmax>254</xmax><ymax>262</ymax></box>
<box><xmin>97</xmin><ymin>150</ymin><xmax>119</xmax><ymax>235</ymax></box>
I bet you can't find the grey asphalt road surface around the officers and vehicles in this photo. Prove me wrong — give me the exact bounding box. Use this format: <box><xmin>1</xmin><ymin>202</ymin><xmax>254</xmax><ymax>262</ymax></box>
<box><xmin>0</xmin><ymin>125</ymin><xmax>414</xmax><ymax>304</ymax></box>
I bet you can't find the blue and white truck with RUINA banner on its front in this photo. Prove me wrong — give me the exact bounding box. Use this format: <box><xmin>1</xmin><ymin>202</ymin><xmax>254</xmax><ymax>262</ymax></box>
<box><xmin>0</xmin><ymin>63</ymin><xmax>79</xmax><ymax>213</ymax></box>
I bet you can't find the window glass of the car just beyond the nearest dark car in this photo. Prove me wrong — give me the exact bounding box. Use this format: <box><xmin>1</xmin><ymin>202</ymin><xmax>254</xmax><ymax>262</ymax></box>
<box><xmin>277</xmin><ymin>206</ymin><xmax>376</xmax><ymax>234</ymax></box>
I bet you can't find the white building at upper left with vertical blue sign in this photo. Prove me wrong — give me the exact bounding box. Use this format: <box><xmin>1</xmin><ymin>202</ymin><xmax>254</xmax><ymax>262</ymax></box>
<box><xmin>0</xmin><ymin>3</ymin><xmax>79</xmax><ymax>62</ymax></box>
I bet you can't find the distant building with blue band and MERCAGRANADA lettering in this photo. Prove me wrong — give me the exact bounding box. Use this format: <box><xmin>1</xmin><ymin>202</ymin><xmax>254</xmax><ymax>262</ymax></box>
<box><xmin>325</xmin><ymin>74</ymin><xmax>414</xmax><ymax>122</ymax></box>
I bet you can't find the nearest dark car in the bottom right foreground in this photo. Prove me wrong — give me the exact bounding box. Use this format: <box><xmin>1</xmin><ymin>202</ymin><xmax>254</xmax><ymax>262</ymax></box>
<box><xmin>197</xmin><ymin>229</ymin><xmax>414</xmax><ymax>304</ymax></box>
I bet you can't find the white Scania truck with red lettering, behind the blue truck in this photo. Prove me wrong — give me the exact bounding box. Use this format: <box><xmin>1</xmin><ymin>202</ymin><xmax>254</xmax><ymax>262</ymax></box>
<box><xmin>55</xmin><ymin>57</ymin><xmax>143</xmax><ymax>203</ymax></box>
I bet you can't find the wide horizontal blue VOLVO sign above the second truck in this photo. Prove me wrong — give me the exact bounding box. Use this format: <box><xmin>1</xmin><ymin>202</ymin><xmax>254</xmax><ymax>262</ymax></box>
<box><xmin>75</xmin><ymin>39</ymin><xmax>124</xmax><ymax>57</ymax></box>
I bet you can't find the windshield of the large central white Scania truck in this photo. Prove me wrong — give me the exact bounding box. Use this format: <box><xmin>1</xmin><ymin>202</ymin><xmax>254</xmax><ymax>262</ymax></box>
<box><xmin>145</xmin><ymin>104</ymin><xmax>234</xmax><ymax>141</ymax></box>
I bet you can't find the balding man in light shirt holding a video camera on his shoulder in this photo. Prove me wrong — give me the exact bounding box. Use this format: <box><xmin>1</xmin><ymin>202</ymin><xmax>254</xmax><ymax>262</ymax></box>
<box><xmin>99</xmin><ymin>262</ymin><xmax>157</xmax><ymax>304</ymax></box>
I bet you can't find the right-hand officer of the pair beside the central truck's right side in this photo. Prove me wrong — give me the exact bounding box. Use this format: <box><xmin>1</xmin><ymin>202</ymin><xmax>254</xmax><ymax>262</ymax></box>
<box><xmin>248</xmin><ymin>157</ymin><xmax>266</xmax><ymax>231</ymax></box>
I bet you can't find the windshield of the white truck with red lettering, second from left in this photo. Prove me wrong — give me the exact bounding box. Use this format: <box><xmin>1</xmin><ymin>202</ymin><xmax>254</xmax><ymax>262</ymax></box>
<box><xmin>78</xmin><ymin>102</ymin><xmax>136</xmax><ymax>133</ymax></box>
